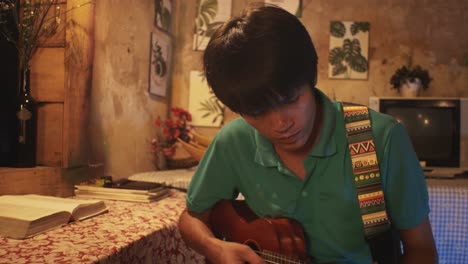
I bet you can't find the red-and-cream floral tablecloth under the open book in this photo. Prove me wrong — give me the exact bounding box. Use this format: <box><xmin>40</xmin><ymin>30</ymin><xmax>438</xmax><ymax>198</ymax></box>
<box><xmin>0</xmin><ymin>192</ymin><xmax>205</xmax><ymax>264</ymax></box>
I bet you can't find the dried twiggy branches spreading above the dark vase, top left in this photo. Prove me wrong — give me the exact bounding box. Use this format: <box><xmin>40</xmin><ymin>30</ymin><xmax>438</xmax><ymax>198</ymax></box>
<box><xmin>0</xmin><ymin>0</ymin><xmax>93</xmax><ymax>69</ymax></box>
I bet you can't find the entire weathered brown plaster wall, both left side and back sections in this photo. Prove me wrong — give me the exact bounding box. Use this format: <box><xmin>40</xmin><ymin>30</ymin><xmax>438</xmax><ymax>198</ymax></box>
<box><xmin>90</xmin><ymin>0</ymin><xmax>468</xmax><ymax>177</ymax></box>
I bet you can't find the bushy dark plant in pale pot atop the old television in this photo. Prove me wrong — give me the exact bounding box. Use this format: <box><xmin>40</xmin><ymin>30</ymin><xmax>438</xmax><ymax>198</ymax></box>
<box><xmin>390</xmin><ymin>57</ymin><xmax>432</xmax><ymax>97</ymax></box>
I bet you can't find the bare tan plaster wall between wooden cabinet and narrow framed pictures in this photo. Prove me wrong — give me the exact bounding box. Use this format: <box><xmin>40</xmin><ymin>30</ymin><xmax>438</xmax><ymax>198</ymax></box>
<box><xmin>89</xmin><ymin>0</ymin><xmax>167</xmax><ymax>178</ymax></box>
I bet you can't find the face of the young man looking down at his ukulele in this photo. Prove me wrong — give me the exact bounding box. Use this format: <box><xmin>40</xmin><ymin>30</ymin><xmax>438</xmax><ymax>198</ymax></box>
<box><xmin>243</xmin><ymin>84</ymin><xmax>316</xmax><ymax>152</ymax></box>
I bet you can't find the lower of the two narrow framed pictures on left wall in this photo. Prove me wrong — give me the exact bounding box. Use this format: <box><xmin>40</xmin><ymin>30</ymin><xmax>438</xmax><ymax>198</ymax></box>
<box><xmin>149</xmin><ymin>28</ymin><xmax>172</xmax><ymax>97</ymax></box>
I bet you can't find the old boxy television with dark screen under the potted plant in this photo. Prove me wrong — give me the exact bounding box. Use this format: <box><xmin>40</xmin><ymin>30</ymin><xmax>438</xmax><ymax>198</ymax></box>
<box><xmin>369</xmin><ymin>97</ymin><xmax>468</xmax><ymax>177</ymax></box>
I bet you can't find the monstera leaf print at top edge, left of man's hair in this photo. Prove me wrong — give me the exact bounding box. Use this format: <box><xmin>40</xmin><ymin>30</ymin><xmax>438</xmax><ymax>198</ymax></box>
<box><xmin>193</xmin><ymin>0</ymin><xmax>232</xmax><ymax>50</ymax></box>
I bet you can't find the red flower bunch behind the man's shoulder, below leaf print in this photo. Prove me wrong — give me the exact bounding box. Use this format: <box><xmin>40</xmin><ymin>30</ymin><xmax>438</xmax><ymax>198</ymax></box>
<box><xmin>151</xmin><ymin>107</ymin><xmax>192</xmax><ymax>158</ymax></box>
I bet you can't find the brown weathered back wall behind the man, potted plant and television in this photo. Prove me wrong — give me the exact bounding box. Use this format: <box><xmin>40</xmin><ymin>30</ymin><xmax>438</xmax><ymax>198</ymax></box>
<box><xmin>172</xmin><ymin>0</ymin><xmax>468</xmax><ymax>106</ymax></box>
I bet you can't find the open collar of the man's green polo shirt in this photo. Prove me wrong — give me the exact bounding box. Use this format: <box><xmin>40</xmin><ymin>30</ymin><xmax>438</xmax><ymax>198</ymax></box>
<box><xmin>254</xmin><ymin>89</ymin><xmax>337</xmax><ymax>167</ymax></box>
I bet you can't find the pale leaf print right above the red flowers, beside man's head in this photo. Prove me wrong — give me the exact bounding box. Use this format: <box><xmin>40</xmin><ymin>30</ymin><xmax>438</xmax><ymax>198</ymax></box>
<box><xmin>189</xmin><ymin>71</ymin><xmax>225</xmax><ymax>127</ymax></box>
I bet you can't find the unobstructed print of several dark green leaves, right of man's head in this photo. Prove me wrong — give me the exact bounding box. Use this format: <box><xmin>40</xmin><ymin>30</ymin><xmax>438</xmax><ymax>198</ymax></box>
<box><xmin>328</xmin><ymin>21</ymin><xmax>370</xmax><ymax>79</ymax></box>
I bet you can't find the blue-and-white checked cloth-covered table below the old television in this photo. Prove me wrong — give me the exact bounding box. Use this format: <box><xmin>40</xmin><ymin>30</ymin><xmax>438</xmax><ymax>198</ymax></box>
<box><xmin>426</xmin><ymin>178</ymin><xmax>468</xmax><ymax>264</ymax></box>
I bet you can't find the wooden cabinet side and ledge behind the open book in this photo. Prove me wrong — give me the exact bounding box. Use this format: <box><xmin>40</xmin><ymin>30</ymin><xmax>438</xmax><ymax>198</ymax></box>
<box><xmin>0</xmin><ymin>0</ymin><xmax>96</xmax><ymax>197</ymax></box>
